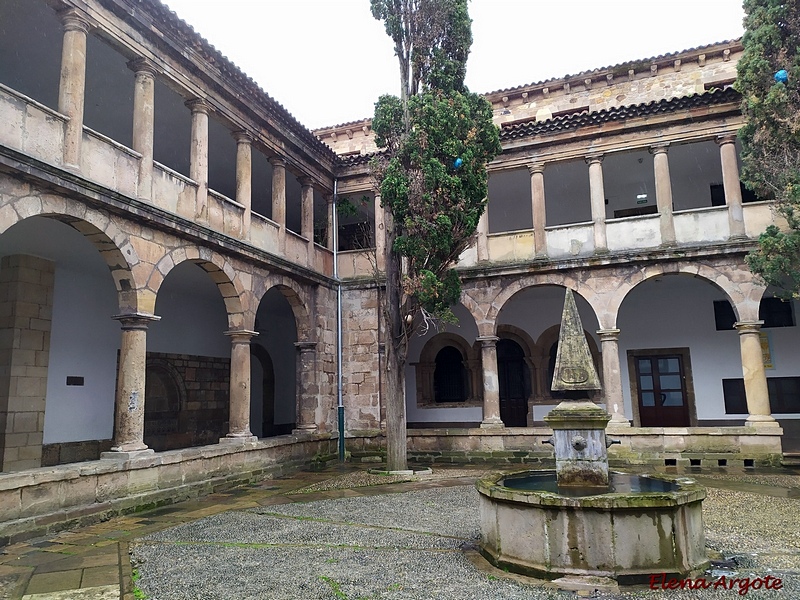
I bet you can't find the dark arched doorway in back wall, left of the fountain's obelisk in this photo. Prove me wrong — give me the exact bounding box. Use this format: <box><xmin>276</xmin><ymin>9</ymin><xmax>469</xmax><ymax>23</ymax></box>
<box><xmin>497</xmin><ymin>339</ymin><xmax>530</xmax><ymax>427</ymax></box>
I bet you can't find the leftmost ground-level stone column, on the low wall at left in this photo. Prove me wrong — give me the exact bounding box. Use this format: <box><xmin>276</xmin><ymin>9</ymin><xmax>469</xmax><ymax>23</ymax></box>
<box><xmin>102</xmin><ymin>313</ymin><xmax>160</xmax><ymax>459</ymax></box>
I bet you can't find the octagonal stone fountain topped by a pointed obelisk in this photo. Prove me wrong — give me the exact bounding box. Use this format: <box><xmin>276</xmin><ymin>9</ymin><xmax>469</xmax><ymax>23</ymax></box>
<box><xmin>477</xmin><ymin>289</ymin><xmax>708</xmax><ymax>584</ymax></box>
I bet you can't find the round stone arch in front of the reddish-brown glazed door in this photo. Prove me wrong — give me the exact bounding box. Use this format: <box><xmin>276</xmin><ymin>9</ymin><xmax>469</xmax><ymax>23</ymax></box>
<box><xmin>598</xmin><ymin>262</ymin><xmax>767</xmax><ymax>329</ymax></box>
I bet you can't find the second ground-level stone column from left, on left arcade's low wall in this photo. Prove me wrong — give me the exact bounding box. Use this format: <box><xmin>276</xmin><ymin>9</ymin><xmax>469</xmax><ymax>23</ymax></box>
<box><xmin>220</xmin><ymin>329</ymin><xmax>258</xmax><ymax>443</ymax></box>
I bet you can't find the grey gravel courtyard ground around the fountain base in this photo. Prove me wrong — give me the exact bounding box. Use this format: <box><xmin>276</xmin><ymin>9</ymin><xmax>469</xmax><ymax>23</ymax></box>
<box><xmin>132</xmin><ymin>472</ymin><xmax>800</xmax><ymax>600</ymax></box>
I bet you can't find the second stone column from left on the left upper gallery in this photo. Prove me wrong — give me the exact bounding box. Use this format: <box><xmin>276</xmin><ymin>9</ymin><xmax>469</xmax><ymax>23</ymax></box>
<box><xmin>128</xmin><ymin>58</ymin><xmax>156</xmax><ymax>200</ymax></box>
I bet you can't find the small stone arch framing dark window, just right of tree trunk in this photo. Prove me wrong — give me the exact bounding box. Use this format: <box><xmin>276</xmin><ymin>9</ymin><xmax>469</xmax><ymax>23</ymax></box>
<box><xmin>414</xmin><ymin>332</ymin><xmax>483</xmax><ymax>406</ymax></box>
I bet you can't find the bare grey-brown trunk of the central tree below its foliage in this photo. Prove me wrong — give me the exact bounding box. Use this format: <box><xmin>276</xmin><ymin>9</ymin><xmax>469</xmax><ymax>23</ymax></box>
<box><xmin>382</xmin><ymin>231</ymin><xmax>408</xmax><ymax>471</ymax></box>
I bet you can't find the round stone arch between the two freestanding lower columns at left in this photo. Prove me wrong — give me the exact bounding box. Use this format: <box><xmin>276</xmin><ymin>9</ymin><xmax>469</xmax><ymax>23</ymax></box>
<box><xmin>152</xmin><ymin>246</ymin><xmax>248</xmax><ymax>330</ymax></box>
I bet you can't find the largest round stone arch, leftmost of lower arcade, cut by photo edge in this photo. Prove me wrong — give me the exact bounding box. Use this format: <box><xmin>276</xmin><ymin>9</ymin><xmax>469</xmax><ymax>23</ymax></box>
<box><xmin>0</xmin><ymin>202</ymin><xmax>141</xmax><ymax>314</ymax></box>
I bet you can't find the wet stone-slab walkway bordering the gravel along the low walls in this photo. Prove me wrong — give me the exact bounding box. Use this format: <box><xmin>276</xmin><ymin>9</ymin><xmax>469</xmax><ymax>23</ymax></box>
<box><xmin>0</xmin><ymin>466</ymin><xmax>800</xmax><ymax>600</ymax></box>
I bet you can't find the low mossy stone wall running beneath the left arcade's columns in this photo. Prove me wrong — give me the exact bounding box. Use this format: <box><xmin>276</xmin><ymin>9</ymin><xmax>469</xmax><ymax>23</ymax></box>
<box><xmin>0</xmin><ymin>434</ymin><xmax>336</xmax><ymax>545</ymax></box>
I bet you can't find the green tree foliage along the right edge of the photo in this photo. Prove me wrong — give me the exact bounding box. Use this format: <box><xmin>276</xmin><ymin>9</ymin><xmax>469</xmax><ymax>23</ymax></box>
<box><xmin>736</xmin><ymin>0</ymin><xmax>800</xmax><ymax>297</ymax></box>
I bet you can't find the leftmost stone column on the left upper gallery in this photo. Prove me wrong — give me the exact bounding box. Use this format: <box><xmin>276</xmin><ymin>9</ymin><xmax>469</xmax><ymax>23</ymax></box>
<box><xmin>58</xmin><ymin>8</ymin><xmax>89</xmax><ymax>169</ymax></box>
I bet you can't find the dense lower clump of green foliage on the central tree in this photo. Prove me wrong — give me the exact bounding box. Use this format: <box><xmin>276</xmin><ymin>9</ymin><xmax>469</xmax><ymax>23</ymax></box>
<box><xmin>372</xmin><ymin>89</ymin><xmax>499</xmax><ymax>321</ymax></box>
